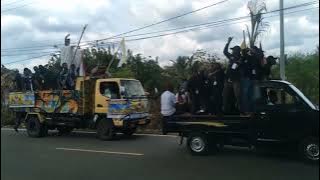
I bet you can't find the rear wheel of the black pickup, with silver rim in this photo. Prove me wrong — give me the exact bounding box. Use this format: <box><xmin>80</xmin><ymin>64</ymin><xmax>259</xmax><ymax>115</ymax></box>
<box><xmin>187</xmin><ymin>133</ymin><xmax>209</xmax><ymax>155</ymax></box>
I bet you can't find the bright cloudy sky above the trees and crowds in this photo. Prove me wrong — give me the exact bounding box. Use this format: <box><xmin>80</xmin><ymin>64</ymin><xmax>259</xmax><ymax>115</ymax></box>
<box><xmin>1</xmin><ymin>0</ymin><xmax>319</xmax><ymax>70</ymax></box>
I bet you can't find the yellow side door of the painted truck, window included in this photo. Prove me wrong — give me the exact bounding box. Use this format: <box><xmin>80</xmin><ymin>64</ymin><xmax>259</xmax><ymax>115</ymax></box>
<box><xmin>95</xmin><ymin>81</ymin><xmax>120</xmax><ymax>114</ymax></box>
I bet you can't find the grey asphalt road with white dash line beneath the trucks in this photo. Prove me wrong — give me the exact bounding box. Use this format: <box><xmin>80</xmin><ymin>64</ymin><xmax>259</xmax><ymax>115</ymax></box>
<box><xmin>1</xmin><ymin>129</ymin><xmax>319</xmax><ymax>180</ymax></box>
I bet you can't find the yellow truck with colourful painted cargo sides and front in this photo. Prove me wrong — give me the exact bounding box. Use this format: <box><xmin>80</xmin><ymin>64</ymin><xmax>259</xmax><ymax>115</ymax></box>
<box><xmin>9</xmin><ymin>77</ymin><xmax>150</xmax><ymax>140</ymax></box>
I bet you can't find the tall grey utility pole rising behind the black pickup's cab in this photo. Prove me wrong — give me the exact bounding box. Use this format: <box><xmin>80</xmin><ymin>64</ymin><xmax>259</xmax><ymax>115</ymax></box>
<box><xmin>279</xmin><ymin>0</ymin><xmax>286</xmax><ymax>80</ymax></box>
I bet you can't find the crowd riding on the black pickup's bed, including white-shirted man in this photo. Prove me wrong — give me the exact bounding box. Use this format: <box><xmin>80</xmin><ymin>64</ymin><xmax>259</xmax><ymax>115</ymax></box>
<box><xmin>161</xmin><ymin>37</ymin><xmax>277</xmax><ymax>118</ymax></box>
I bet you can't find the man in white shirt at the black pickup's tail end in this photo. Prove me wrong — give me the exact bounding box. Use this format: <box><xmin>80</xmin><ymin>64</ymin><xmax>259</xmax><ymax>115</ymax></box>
<box><xmin>161</xmin><ymin>83</ymin><xmax>177</xmax><ymax>134</ymax></box>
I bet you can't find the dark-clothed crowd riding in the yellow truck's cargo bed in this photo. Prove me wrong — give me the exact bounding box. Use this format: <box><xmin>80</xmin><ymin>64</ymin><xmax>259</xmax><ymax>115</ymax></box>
<box><xmin>15</xmin><ymin>63</ymin><xmax>79</xmax><ymax>91</ymax></box>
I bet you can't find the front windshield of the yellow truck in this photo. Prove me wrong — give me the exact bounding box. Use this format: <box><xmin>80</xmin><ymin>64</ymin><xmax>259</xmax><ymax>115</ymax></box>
<box><xmin>121</xmin><ymin>80</ymin><xmax>145</xmax><ymax>98</ymax></box>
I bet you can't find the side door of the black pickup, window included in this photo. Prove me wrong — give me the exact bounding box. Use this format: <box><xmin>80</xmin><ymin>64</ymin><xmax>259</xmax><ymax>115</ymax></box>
<box><xmin>257</xmin><ymin>86</ymin><xmax>305</xmax><ymax>141</ymax></box>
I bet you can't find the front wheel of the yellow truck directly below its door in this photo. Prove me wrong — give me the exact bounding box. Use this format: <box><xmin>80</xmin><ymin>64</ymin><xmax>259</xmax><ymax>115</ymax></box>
<box><xmin>97</xmin><ymin>119</ymin><xmax>115</xmax><ymax>141</ymax></box>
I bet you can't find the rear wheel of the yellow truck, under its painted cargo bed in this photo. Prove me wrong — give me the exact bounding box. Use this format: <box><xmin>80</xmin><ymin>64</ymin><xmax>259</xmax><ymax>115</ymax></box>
<box><xmin>27</xmin><ymin>116</ymin><xmax>48</xmax><ymax>137</ymax></box>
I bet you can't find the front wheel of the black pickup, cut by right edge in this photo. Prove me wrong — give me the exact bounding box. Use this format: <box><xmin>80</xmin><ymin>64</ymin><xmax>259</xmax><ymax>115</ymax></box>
<box><xmin>300</xmin><ymin>138</ymin><xmax>319</xmax><ymax>163</ymax></box>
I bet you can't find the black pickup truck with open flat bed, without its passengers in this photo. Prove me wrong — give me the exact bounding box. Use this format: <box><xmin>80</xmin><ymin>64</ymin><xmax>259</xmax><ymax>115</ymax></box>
<box><xmin>166</xmin><ymin>80</ymin><xmax>319</xmax><ymax>162</ymax></box>
